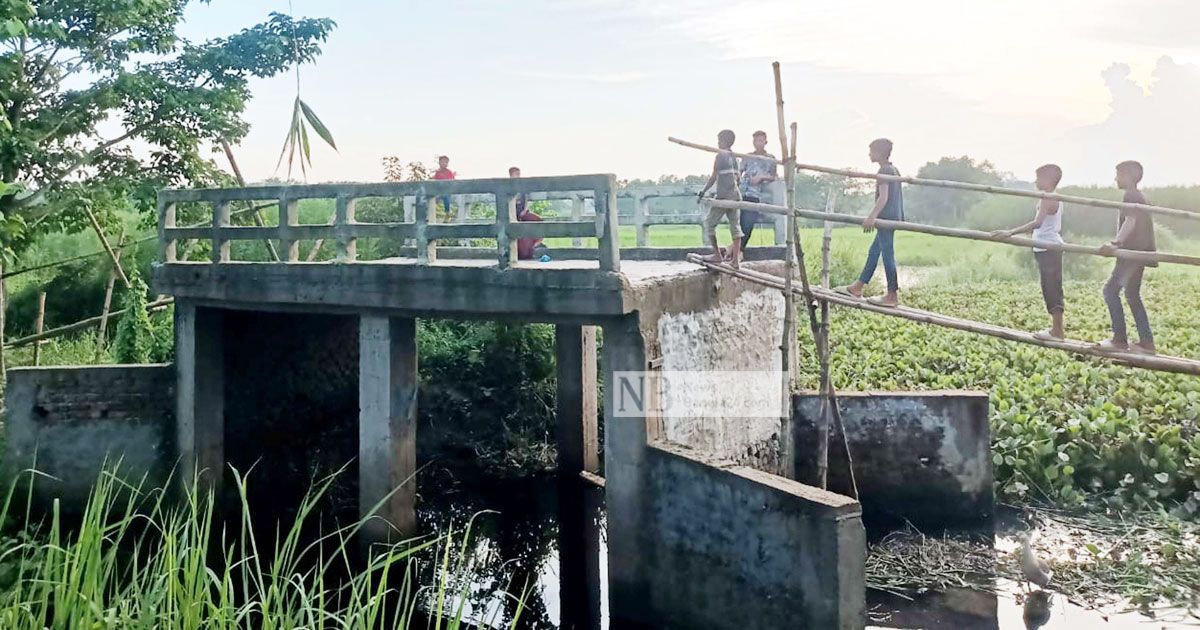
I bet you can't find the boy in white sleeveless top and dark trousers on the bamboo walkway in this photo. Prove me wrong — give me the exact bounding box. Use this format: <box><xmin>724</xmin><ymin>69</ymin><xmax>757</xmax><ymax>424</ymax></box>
<box><xmin>992</xmin><ymin>164</ymin><xmax>1066</xmax><ymax>341</ymax></box>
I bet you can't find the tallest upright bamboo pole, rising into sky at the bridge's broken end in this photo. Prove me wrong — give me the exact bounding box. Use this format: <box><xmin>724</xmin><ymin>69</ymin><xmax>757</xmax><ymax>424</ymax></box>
<box><xmin>770</xmin><ymin>61</ymin><xmax>806</xmax><ymax>479</ymax></box>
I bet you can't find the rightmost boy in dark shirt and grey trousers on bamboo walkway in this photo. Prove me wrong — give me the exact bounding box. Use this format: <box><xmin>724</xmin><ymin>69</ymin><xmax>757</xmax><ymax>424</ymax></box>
<box><xmin>1096</xmin><ymin>161</ymin><xmax>1158</xmax><ymax>354</ymax></box>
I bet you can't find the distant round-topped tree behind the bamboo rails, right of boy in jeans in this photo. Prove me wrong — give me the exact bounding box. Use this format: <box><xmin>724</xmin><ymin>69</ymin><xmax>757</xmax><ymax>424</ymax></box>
<box><xmin>905</xmin><ymin>156</ymin><xmax>1004</xmax><ymax>224</ymax></box>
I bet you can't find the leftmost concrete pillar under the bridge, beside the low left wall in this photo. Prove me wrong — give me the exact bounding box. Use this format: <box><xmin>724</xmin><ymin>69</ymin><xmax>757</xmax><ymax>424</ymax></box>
<box><xmin>175</xmin><ymin>300</ymin><xmax>226</xmax><ymax>496</ymax></box>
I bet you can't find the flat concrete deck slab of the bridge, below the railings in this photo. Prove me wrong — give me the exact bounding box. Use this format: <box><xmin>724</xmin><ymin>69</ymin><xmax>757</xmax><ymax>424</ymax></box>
<box><xmin>152</xmin><ymin>258</ymin><xmax>724</xmax><ymax>322</ymax></box>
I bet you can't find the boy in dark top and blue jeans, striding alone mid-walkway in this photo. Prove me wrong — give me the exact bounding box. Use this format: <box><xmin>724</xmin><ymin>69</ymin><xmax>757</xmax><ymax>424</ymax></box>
<box><xmin>836</xmin><ymin>138</ymin><xmax>904</xmax><ymax>306</ymax></box>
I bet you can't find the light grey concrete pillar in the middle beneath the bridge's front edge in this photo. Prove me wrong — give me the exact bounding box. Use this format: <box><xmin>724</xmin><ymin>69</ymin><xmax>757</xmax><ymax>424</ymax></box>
<box><xmin>359</xmin><ymin>316</ymin><xmax>416</xmax><ymax>542</ymax></box>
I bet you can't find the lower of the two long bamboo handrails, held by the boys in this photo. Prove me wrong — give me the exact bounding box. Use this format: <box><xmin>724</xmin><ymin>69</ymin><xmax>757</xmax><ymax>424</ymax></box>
<box><xmin>704</xmin><ymin>199</ymin><xmax>1200</xmax><ymax>266</ymax></box>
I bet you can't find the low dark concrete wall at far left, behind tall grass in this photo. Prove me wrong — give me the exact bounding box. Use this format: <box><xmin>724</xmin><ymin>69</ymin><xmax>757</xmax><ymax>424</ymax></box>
<box><xmin>4</xmin><ymin>365</ymin><xmax>175</xmax><ymax>512</ymax></box>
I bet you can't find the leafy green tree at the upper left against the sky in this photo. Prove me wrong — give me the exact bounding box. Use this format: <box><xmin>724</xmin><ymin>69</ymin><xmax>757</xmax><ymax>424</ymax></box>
<box><xmin>0</xmin><ymin>0</ymin><xmax>334</xmax><ymax>252</ymax></box>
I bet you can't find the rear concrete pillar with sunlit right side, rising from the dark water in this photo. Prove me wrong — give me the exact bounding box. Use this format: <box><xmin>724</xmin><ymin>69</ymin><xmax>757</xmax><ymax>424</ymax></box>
<box><xmin>554</xmin><ymin>325</ymin><xmax>600</xmax><ymax>476</ymax></box>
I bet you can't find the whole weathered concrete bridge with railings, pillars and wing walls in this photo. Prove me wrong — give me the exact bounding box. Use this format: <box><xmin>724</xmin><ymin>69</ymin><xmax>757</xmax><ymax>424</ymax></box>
<box><xmin>10</xmin><ymin>175</ymin><xmax>991</xmax><ymax>629</ymax></box>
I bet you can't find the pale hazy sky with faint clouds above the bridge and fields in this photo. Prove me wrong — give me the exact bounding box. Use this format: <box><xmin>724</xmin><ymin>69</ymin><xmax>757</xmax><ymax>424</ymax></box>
<box><xmin>184</xmin><ymin>0</ymin><xmax>1200</xmax><ymax>184</ymax></box>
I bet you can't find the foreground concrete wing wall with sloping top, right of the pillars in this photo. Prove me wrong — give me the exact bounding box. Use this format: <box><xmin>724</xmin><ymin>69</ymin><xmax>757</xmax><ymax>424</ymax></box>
<box><xmin>636</xmin><ymin>443</ymin><xmax>865</xmax><ymax>630</ymax></box>
